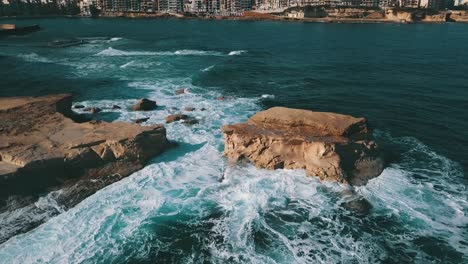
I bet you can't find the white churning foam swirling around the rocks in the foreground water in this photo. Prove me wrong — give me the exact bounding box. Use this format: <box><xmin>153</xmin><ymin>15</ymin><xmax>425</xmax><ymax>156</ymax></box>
<box><xmin>0</xmin><ymin>50</ymin><xmax>468</xmax><ymax>263</ymax></box>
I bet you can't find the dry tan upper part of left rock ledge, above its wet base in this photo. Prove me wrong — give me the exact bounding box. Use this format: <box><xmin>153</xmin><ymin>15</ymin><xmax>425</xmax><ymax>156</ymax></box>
<box><xmin>0</xmin><ymin>94</ymin><xmax>170</xmax><ymax>199</ymax></box>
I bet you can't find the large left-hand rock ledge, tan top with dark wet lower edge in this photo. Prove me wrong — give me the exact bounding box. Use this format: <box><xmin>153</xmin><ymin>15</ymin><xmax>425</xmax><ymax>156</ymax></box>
<box><xmin>0</xmin><ymin>94</ymin><xmax>172</xmax><ymax>244</ymax></box>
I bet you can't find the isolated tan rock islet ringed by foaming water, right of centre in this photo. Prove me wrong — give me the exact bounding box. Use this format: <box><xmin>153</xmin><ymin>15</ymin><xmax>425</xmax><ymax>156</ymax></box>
<box><xmin>222</xmin><ymin>107</ymin><xmax>384</xmax><ymax>185</ymax></box>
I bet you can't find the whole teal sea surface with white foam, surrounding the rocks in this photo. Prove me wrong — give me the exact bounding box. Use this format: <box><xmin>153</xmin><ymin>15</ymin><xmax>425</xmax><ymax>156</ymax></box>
<box><xmin>0</xmin><ymin>19</ymin><xmax>468</xmax><ymax>263</ymax></box>
